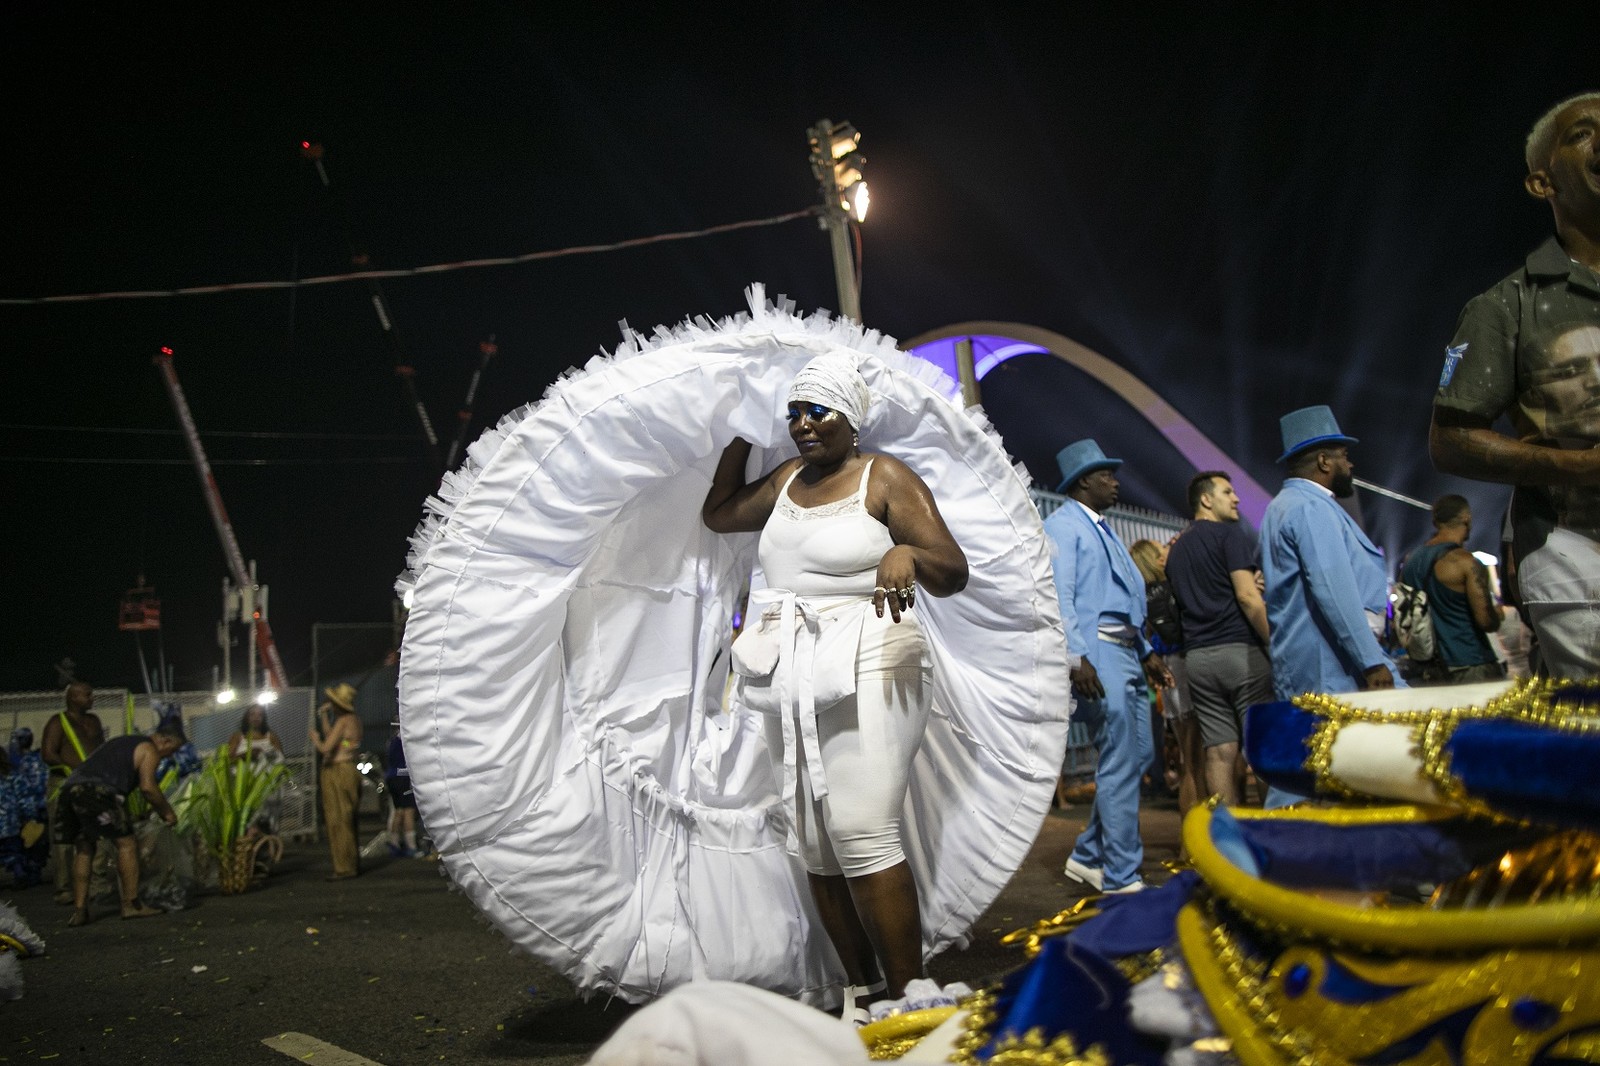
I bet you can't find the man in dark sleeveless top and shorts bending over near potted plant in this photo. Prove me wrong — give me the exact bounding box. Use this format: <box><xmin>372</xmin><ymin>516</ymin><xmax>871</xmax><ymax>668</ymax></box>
<box><xmin>50</xmin><ymin>719</ymin><xmax>186</xmax><ymax>925</ymax></box>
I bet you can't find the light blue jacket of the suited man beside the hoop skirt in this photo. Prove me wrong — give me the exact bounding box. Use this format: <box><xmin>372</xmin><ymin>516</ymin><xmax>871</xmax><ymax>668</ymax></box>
<box><xmin>1045</xmin><ymin>499</ymin><xmax>1150</xmax><ymax>661</ymax></box>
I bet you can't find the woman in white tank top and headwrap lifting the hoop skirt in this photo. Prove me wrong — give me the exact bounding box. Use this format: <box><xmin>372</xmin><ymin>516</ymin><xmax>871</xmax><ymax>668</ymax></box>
<box><xmin>701</xmin><ymin>355</ymin><xmax>966</xmax><ymax>1013</ymax></box>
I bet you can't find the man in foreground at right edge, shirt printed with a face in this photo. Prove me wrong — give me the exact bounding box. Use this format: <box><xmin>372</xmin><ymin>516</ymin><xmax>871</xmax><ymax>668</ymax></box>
<box><xmin>1429</xmin><ymin>93</ymin><xmax>1600</xmax><ymax>677</ymax></box>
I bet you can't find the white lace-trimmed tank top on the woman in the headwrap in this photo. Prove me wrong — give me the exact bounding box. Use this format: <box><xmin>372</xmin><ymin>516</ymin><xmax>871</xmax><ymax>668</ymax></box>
<box><xmin>757</xmin><ymin>459</ymin><xmax>894</xmax><ymax>597</ymax></box>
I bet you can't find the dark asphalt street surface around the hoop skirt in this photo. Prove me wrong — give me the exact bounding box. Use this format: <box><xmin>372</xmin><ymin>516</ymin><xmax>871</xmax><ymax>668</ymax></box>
<box><xmin>0</xmin><ymin>800</ymin><xmax>1178</xmax><ymax>1066</ymax></box>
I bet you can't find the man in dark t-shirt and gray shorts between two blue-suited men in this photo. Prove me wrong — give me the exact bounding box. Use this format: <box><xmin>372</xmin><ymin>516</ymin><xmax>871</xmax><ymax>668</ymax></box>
<box><xmin>1166</xmin><ymin>471</ymin><xmax>1272</xmax><ymax>805</ymax></box>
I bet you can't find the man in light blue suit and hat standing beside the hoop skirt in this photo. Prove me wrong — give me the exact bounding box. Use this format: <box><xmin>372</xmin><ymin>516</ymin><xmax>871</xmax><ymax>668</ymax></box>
<box><xmin>1045</xmin><ymin>440</ymin><xmax>1173</xmax><ymax>893</ymax></box>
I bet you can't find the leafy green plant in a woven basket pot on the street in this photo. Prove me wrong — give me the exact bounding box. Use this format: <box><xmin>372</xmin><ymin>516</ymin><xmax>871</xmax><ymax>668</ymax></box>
<box><xmin>178</xmin><ymin>746</ymin><xmax>290</xmax><ymax>895</ymax></box>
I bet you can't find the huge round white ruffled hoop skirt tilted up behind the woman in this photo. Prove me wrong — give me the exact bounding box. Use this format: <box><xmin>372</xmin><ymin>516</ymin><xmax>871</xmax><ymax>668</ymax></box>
<box><xmin>400</xmin><ymin>288</ymin><xmax>1069</xmax><ymax>1004</ymax></box>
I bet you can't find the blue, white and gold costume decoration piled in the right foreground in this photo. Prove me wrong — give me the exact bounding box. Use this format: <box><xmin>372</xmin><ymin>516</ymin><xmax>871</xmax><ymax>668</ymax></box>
<box><xmin>902</xmin><ymin>682</ymin><xmax>1600</xmax><ymax>1066</ymax></box>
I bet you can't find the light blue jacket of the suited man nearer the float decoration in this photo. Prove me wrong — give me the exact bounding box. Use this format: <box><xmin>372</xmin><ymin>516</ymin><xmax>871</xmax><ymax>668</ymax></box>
<box><xmin>1261</xmin><ymin>477</ymin><xmax>1402</xmax><ymax>699</ymax></box>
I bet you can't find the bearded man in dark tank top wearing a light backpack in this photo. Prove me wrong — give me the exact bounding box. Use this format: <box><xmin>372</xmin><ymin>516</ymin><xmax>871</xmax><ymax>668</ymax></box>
<box><xmin>1395</xmin><ymin>495</ymin><xmax>1506</xmax><ymax>685</ymax></box>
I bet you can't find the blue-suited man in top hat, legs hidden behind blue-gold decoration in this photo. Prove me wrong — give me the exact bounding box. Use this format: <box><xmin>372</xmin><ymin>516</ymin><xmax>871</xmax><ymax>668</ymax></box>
<box><xmin>1261</xmin><ymin>405</ymin><xmax>1403</xmax><ymax>807</ymax></box>
